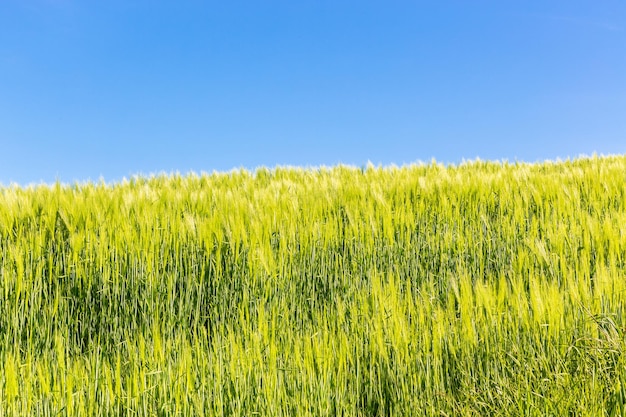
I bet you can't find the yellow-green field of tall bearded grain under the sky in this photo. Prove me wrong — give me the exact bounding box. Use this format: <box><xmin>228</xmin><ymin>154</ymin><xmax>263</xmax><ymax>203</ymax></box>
<box><xmin>0</xmin><ymin>156</ymin><xmax>626</xmax><ymax>417</ymax></box>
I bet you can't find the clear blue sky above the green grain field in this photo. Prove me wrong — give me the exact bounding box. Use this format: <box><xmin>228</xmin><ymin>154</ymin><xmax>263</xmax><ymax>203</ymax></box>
<box><xmin>0</xmin><ymin>0</ymin><xmax>626</xmax><ymax>184</ymax></box>
